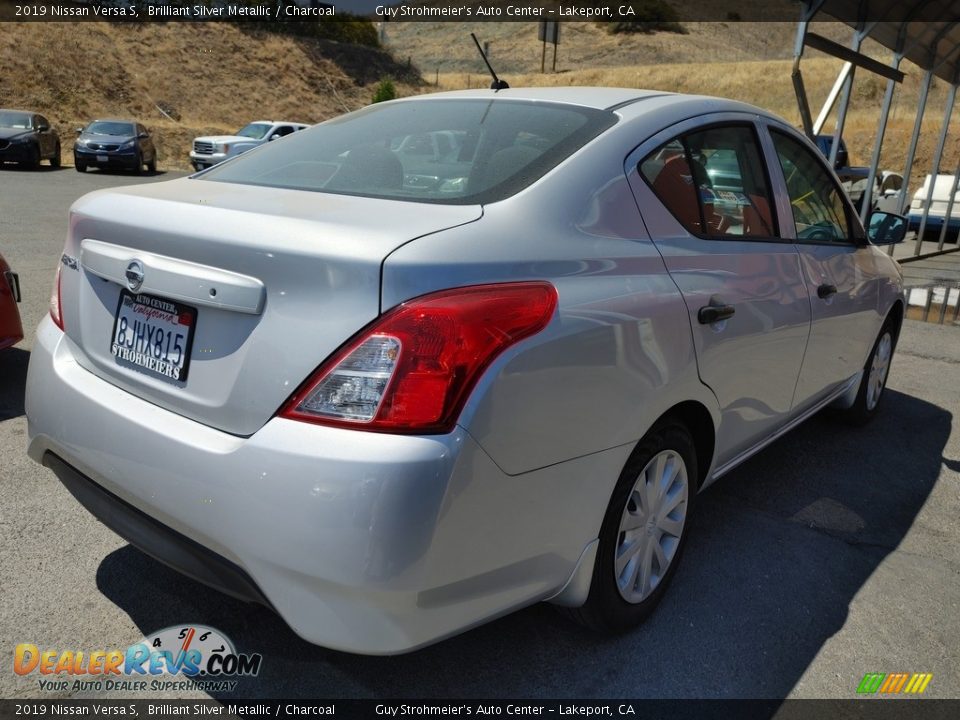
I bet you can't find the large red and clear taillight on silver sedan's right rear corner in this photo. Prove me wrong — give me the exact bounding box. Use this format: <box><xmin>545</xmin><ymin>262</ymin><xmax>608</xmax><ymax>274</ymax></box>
<box><xmin>280</xmin><ymin>282</ymin><xmax>557</xmax><ymax>433</ymax></box>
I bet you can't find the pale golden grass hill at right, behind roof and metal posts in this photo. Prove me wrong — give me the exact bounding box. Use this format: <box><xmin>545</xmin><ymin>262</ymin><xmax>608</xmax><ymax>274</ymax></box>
<box><xmin>386</xmin><ymin>22</ymin><xmax>960</xmax><ymax>193</ymax></box>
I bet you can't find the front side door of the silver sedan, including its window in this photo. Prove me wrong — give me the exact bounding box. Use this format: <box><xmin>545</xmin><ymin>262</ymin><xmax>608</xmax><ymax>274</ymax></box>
<box><xmin>769</xmin><ymin>125</ymin><xmax>883</xmax><ymax>407</ymax></box>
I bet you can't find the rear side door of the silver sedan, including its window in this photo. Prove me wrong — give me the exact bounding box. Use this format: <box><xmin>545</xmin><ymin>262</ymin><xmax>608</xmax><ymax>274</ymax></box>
<box><xmin>626</xmin><ymin>113</ymin><xmax>810</xmax><ymax>467</ymax></box>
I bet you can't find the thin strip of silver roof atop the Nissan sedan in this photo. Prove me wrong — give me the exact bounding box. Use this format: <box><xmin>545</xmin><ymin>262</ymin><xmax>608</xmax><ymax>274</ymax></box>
<box><xmin>399</xmin><ymin>87</ymin><xmax>779</xmax><ymax>119</ymax></box>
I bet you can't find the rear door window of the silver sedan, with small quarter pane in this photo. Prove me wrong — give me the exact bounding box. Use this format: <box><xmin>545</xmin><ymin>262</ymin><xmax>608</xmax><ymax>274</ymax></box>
<box><xmin>639</xmin><ymin>126</ymin><xmax>777</xmax><ymax>238</ymax></box>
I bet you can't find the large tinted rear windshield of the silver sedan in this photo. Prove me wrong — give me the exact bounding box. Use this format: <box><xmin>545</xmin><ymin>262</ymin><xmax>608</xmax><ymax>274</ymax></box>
<box><xmin>198</xmin><ymin>99</ymin><xmax>616</xmax><ymax>205</ymax></box>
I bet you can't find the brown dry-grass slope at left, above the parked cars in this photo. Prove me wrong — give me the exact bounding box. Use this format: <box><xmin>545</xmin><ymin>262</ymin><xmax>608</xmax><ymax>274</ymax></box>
<box><xmin>0</xmin><ymin>22</ymin><xmax>419</xmax><ymax>168</ymax></box>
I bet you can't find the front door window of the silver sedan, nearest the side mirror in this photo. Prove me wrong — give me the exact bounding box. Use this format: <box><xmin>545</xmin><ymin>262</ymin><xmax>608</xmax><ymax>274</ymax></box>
<box><xmin>770</xmin><ymin>131</ymin><xmax>852</xmax><ymax>244</ymax></box>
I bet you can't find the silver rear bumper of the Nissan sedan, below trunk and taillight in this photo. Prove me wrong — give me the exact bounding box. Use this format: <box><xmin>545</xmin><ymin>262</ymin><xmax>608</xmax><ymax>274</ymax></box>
<box><xmin>26</xmin><ymin>320</ymin><xmax>604</xmax><ymax>654</ymax></box>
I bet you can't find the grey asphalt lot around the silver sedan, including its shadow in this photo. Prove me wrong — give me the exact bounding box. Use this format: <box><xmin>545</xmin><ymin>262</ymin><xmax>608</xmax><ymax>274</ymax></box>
<box><xmin>0</xmin><ymin>168</ymin><xmax>960</xmax><ymax>700</ymax></box>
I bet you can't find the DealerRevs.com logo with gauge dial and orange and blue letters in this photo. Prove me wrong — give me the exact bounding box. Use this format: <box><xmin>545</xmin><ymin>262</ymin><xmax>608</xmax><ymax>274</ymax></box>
<box><xmin>13</xmin><ymin>625</ymin><xmax>263</xmax><ymax>692</ymax></box>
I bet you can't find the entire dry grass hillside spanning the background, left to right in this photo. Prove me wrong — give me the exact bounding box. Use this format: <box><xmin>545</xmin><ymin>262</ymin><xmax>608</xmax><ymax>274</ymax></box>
<box><xmin>0</xmin><ymin>22</ymin><xmax>960</xmax><ymax>187</ymax></box>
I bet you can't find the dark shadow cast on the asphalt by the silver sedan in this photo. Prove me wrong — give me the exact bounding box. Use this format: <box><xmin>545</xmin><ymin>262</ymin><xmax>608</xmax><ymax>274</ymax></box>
<box><xmin>97</xmin><ymin>390</ymin><xmax>952</xmax><ymax>701</ymax></box>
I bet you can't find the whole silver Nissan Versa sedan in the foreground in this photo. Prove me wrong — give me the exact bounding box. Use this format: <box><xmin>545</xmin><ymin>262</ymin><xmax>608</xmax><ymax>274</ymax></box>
<box><xmin>26</xmin><ymin>88</ymin><xmax>905</xmax><ymax>654</ymax></box>
